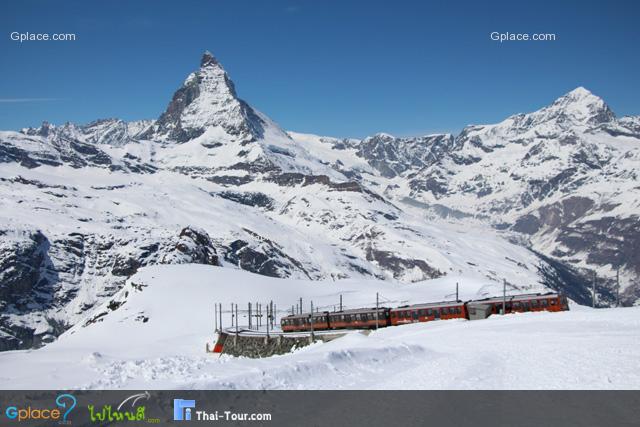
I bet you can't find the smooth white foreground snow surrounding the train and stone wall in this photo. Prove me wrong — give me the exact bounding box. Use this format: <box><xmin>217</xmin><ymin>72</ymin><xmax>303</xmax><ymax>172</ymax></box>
<box><xmin>0</xmin><ymin>265</ymin><xmax>640</xmax><ymax>389</ymax></box>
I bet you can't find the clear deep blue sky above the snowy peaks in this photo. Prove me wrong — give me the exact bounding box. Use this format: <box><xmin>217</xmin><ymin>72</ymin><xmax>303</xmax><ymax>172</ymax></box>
<box><xmin>0</xmin><ymin>0</ymin><xmax>640</xmax><ymax>137</ymax></box>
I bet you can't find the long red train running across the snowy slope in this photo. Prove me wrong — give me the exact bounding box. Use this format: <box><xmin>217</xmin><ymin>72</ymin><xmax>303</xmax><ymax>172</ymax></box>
<box><xmin>280</xmin><ymin>293</ymin><xmax>569</xmax><ymax>332</ymax></box>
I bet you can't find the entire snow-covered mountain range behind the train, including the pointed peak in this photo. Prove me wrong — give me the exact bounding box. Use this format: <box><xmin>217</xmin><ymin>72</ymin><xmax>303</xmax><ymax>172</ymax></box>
<box><xmin>0</xmin><ymin>53</ymin><xmax>640</xmax><ymax>350</ymax></box>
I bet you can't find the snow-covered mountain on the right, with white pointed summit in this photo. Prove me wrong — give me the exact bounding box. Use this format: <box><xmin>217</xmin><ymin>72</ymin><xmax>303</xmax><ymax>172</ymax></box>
<box><xmin>362</xmin><ymin>88</ymin><xmax>640</xmax><ymax>302</ymax></box>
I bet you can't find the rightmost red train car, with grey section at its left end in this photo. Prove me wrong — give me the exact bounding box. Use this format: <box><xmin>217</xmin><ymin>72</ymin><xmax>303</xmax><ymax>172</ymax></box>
<box><xmin>467</xmin><ymin>292</ymin><xmax>569</xmax><ymax>320</ymax></box>
